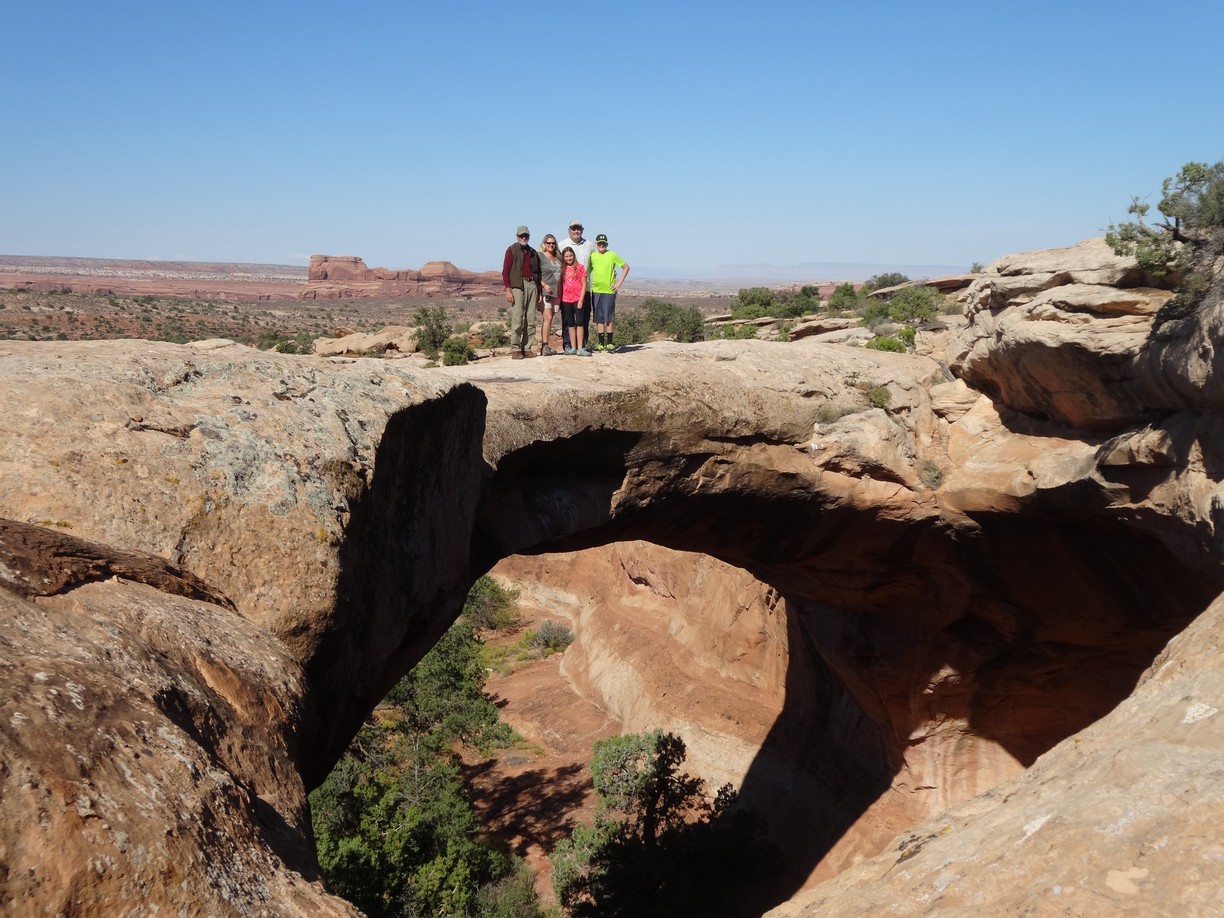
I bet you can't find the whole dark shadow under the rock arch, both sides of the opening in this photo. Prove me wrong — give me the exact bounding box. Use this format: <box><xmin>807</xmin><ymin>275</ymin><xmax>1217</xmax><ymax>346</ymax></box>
<box><xmin>300</xmin><ymin>386</ymin><xmax>1224</xmax><ymax>909</ymax></box>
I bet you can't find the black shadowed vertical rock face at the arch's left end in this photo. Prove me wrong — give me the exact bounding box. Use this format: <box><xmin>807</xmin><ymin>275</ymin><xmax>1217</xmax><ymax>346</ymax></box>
<box><xmin>298</xmin><ymin>386</ymin><xmax>487</xmax><ymax>788</ymax></box>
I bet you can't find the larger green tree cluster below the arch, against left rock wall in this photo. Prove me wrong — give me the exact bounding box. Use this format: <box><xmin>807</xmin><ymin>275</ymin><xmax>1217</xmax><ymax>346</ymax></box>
<box><xmin>311</xmin><ymin>604</ymin><xmax>542</xmax><ymax>918</ymax></box>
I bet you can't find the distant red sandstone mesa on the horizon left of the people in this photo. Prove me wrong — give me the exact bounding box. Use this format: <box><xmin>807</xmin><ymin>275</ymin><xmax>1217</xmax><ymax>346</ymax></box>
<box><xmin>297</xmin><ymin>255</ymin><xmax>502</xmax><ymax>300</ymax></box>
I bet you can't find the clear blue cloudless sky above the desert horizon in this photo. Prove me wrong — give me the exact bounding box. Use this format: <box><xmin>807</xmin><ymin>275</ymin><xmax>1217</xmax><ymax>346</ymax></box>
<box><xmin>0</xmin><ymin>0</ymin><xmax>1224</xmax><ymax>277</ymax></box>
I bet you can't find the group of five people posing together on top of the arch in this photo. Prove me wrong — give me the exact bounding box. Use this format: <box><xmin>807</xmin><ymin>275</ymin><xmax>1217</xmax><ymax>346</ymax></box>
<box><xmin>502</xmin><ymin>220</ymin><xmax>629</xmax><ymax>360</ymax></box>
